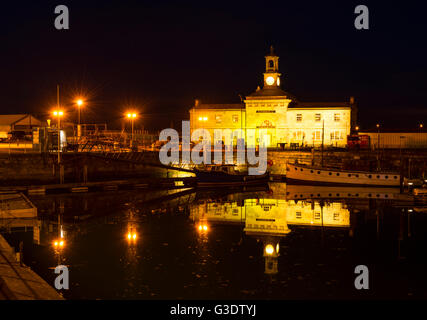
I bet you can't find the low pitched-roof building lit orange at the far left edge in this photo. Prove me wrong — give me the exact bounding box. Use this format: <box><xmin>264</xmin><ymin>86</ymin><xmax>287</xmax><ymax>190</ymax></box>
<box><xmin>0</xmin><ymin>114</ymin><xmax>42</xmax><ymax>138</ymax></box>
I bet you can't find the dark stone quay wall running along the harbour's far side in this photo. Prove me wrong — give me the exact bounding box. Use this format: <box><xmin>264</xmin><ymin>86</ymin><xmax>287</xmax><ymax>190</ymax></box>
<box><xmin>0</xmin><ymin>150</ymin><xmax>427</xmax><ymax>186</ymax></box>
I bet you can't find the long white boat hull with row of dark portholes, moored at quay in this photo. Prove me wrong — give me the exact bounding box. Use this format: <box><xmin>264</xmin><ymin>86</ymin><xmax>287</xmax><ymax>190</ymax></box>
<box><xmin>286</xmin><ymin>163</ymin><xmax>401</xmax><ymax>187</ymax></box>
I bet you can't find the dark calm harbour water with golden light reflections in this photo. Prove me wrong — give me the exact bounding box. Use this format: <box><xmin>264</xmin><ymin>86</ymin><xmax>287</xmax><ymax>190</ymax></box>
<box><xmin>0</xmin><ymin>183</ymin><xmax>427</xmax><ymax>299</ymax></box>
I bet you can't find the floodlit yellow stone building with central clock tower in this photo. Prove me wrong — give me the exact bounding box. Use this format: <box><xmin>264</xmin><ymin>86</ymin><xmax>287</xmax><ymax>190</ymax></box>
<box><xmin>190</xmin><ymin>47</ymin><xmax>356</xmax><ymax>147</ymax></box>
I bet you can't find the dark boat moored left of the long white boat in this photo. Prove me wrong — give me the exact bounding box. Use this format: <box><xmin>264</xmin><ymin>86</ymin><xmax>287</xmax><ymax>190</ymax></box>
<box><xmin>194</xmin><ymin>165</ymin><xmax>270</xmax><ymax>187</ymax></box>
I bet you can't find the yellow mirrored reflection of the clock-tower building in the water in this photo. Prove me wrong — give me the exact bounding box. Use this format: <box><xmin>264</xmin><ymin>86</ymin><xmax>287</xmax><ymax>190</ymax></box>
<box><xmin>190</xmin><ymin>195</ymin><xmax>350</xmax><ymax>275</ymax></box>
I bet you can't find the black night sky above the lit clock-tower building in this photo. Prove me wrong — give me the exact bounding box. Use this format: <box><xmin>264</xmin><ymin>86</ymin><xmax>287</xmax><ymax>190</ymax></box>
<box><xmin>0</xmin><ymin>0</ymin><xmax>427</xmax><ymax>128</ymax></box>
